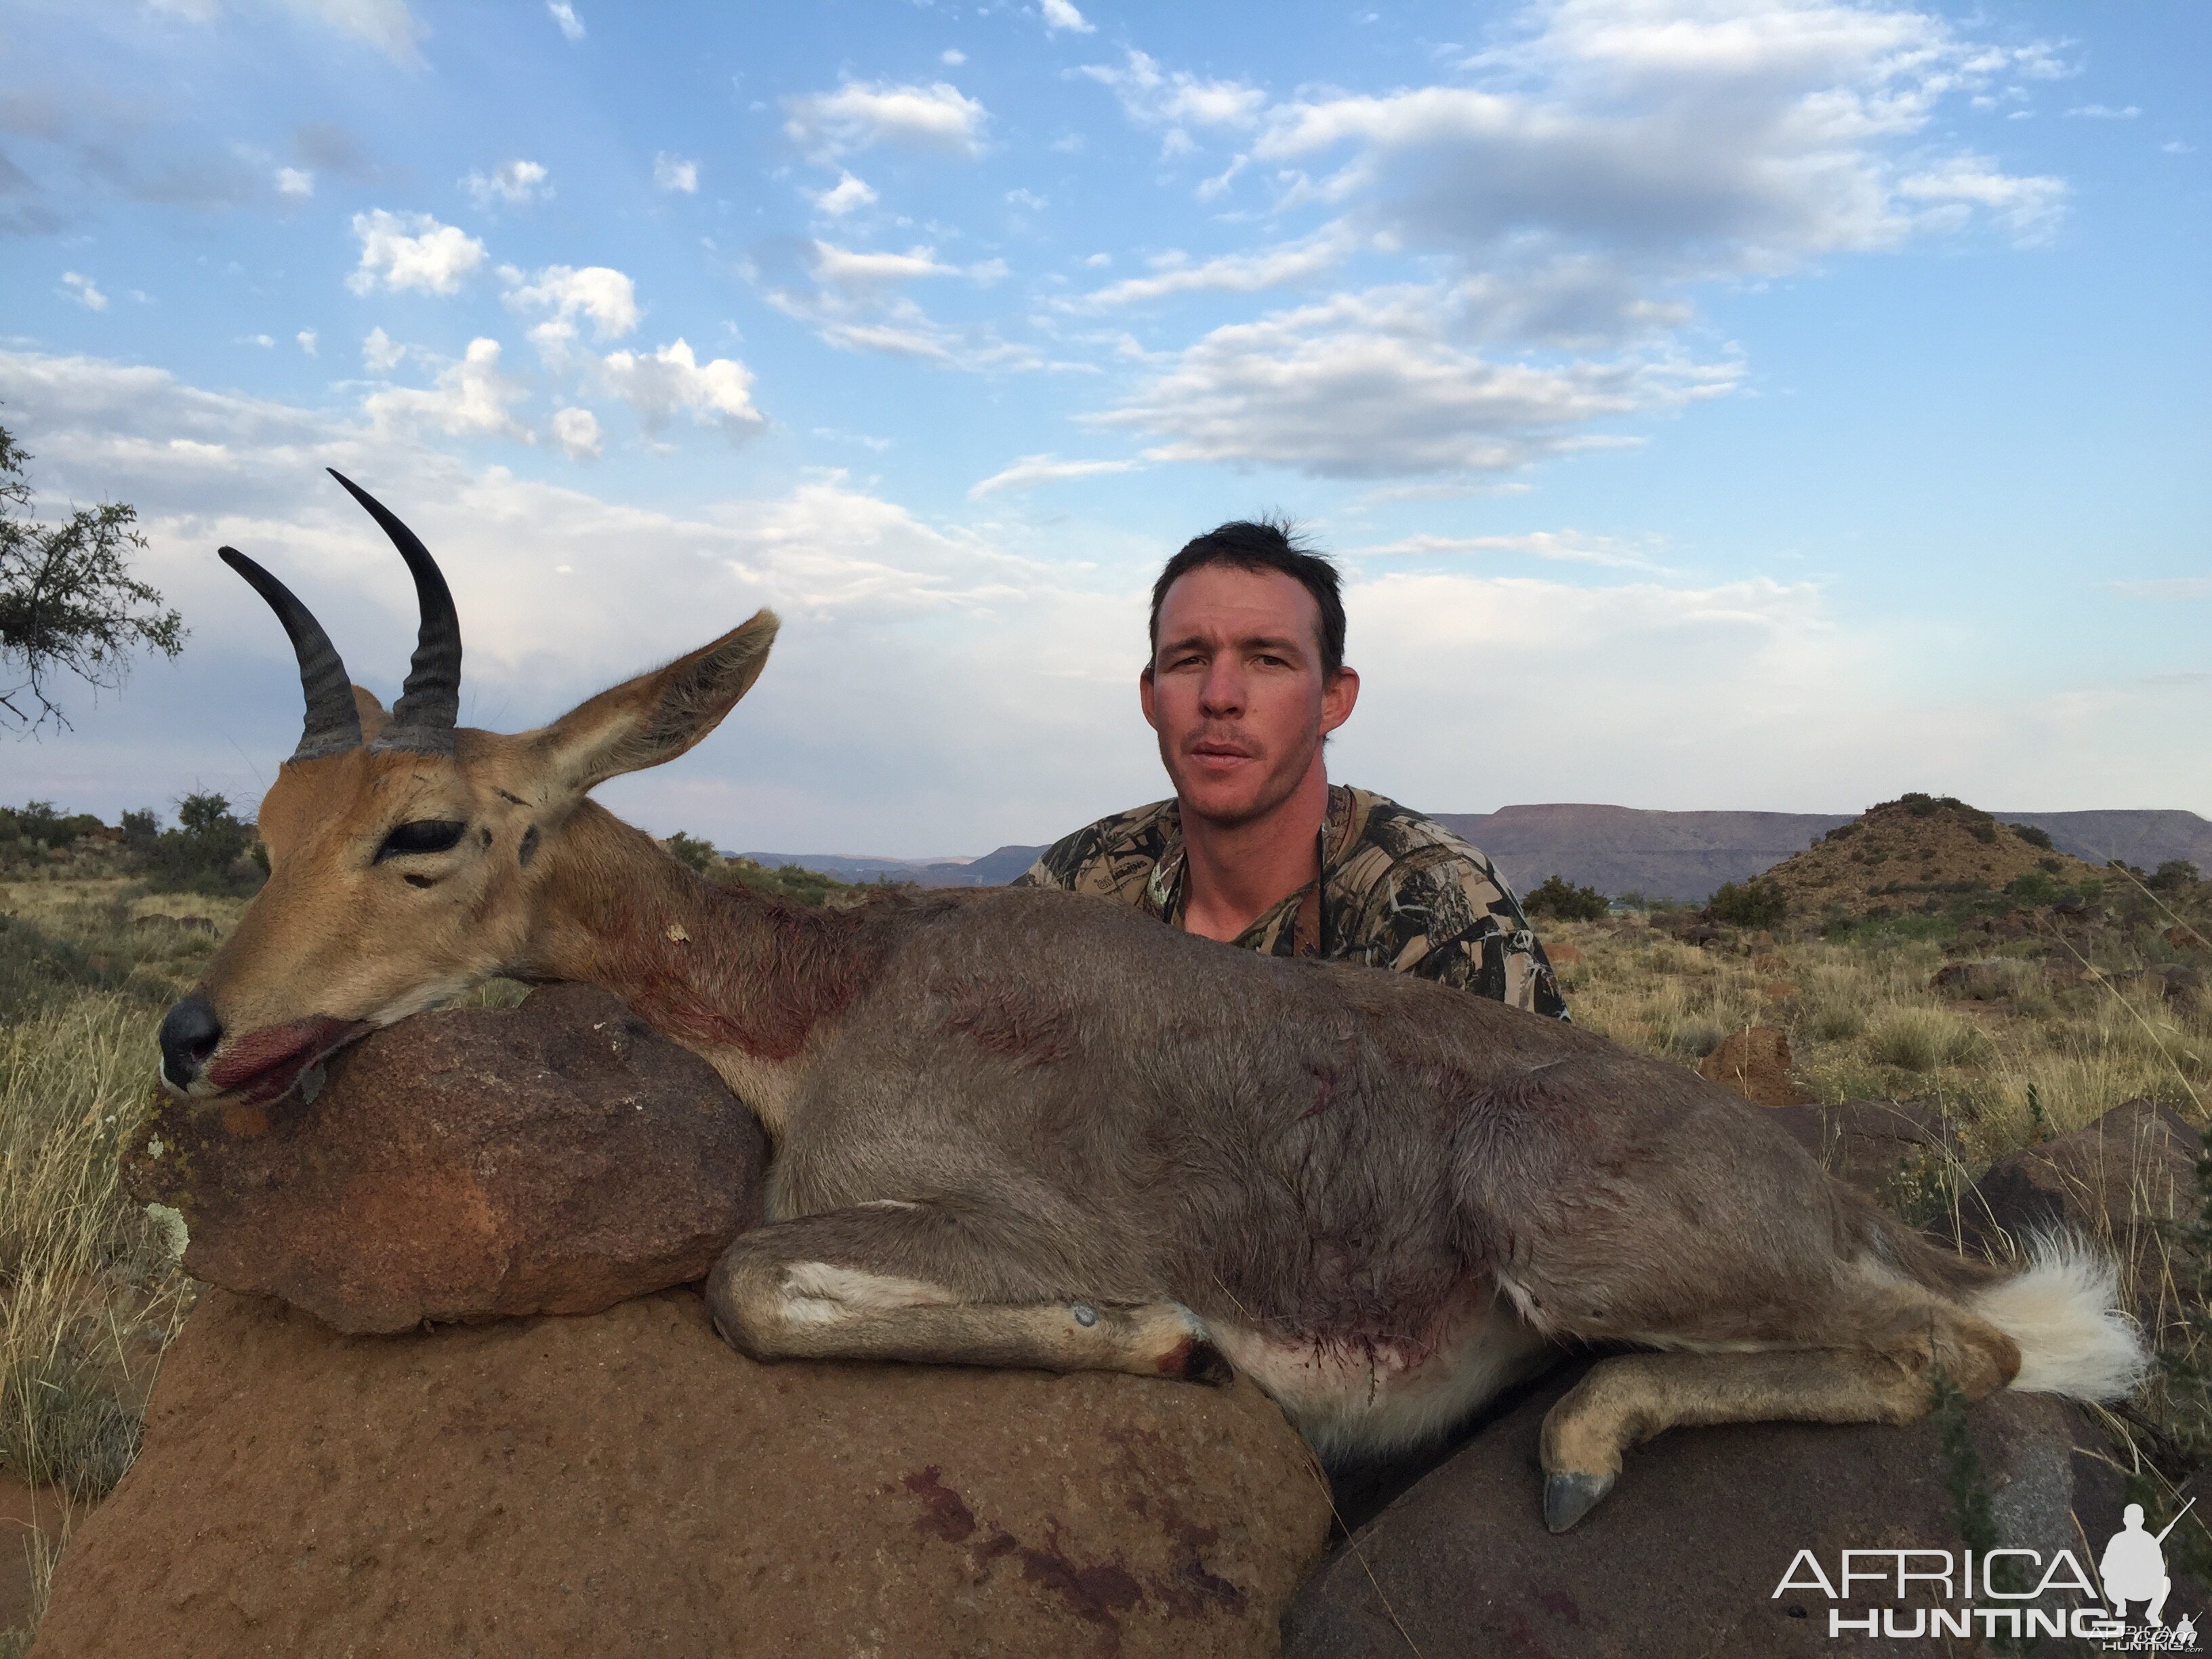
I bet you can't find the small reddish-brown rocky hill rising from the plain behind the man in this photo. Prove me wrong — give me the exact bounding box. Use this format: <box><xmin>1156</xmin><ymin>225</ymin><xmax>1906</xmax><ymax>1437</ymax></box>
<box><xmin>1763</xmin><ymin>794</ymin><xmax>2104</xmax><ymax>922</ymax></box>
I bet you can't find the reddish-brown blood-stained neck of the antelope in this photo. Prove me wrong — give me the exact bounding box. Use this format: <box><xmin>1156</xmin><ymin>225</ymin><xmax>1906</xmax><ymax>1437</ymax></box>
<box><xmin>513</xmin><ymin>801</ymin><xmax>902</xmax><ymax>1132</ymax></box>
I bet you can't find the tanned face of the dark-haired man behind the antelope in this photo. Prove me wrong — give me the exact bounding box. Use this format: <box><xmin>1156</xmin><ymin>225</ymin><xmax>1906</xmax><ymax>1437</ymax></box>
<box><xmin>1137</xmin><ymin>564</ymin><xmax>1360</xmax><ymax>825</ymax></box>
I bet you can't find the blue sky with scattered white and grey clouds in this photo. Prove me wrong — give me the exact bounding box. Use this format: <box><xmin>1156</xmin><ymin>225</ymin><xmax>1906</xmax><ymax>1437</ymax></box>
<box><xmin>0</xmin><ymin>0</ymin><xmax>2212</xmax><ymax>856</ymax></box>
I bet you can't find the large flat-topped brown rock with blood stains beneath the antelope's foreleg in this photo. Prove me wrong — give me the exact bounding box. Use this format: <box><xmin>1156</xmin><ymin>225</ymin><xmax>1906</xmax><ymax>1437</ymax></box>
<box><xmin>37</xmin><ymin>1290</ymin><xmax>1330</xmax><ymax>1659</ymax></box>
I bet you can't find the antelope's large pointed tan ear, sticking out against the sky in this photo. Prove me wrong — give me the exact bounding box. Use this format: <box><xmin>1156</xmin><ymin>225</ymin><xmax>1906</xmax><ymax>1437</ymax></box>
<box><xmin>533</xmin><ymin>611</ymin><xmax>779</xmax><ymax>794</ymax></box>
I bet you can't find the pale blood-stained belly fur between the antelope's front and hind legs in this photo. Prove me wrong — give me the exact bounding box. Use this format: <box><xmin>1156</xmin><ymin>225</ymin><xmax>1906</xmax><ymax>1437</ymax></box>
<box><xmin>1210</xmin><ymin>1296</ymin><xmax>1553</xmax><ymax>1458</ymax></box>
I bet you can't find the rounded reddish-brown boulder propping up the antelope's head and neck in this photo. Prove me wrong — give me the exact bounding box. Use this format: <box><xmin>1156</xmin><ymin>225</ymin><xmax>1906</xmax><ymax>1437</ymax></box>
<box><xmin>124</xmin><ymin>984</ymin><xmax>765</xmax><ymax>1332</ymax></box>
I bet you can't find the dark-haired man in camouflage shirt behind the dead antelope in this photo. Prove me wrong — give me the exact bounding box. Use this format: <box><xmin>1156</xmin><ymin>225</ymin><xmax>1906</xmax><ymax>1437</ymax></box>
<box><xmin>1020</xmin><ymin>522</ymin><xmax>1566</xmax><ymax>1020</ymax></box>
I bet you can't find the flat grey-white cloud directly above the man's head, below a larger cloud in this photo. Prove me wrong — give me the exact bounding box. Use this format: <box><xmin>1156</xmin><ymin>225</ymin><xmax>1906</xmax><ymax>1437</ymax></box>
<box><xmin>1092</xmin><ymin>287</ymin><xmax>1739</xmax><ymax>478</ymax></box>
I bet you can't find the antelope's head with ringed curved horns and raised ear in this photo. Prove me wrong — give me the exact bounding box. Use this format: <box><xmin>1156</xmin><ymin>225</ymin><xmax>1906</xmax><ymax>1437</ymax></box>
<box><xmin>161</xmin><ymin>471</ymin><xmax>777</xmax><ymax>1106</ymax></box>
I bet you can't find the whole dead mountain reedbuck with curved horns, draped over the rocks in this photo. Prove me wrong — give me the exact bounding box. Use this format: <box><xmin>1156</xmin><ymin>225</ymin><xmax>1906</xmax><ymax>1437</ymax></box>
<box><xmin>161</xmin><ymin>478</ymin><xmax>2144</xmax><ymax>1531</ymax></box>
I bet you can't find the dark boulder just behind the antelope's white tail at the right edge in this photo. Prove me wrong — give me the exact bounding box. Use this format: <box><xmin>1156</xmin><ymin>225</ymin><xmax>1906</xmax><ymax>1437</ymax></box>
<box><xmin>1958</xmin><ymin>1099</ymin><xmax>2203</xmax><ymax>1336</ymax></box>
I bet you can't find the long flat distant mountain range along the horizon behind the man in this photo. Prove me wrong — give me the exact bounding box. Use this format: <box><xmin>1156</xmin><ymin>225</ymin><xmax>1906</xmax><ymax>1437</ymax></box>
<box><xmin>745</xmin><ymin>803</ymin><xmax>2212</xmax><ymax>903</ymax></box>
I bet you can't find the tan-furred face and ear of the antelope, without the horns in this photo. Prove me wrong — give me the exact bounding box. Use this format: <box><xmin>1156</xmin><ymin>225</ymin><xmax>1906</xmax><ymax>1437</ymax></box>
<box><xmin>168</xmin><ymin>611</ymin><xmax>777</xmax><ymax>1099</ymax></box>
